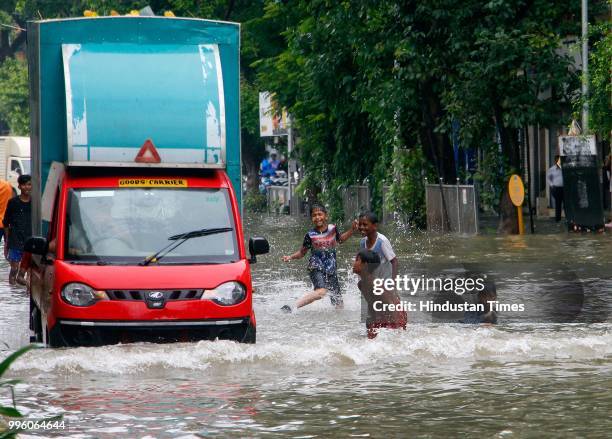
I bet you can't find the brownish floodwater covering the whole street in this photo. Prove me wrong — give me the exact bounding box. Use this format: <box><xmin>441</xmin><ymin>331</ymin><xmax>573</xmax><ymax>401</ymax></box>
<box><xmin>0</xmin><ymin>216</ymin><xmax>612</xmax><ymax>438</ymax></box>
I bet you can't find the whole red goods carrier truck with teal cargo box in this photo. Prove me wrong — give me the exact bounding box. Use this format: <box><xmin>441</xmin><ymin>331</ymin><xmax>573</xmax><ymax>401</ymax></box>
<box><xmin>26</xmin><ymin>17</ymin><xmax>269</xmax><ymax>346</ymax></box>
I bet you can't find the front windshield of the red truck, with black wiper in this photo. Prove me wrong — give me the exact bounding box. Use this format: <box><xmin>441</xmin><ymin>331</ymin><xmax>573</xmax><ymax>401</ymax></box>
<box><xmin>65</xmin><ymin>188</ymin><xmax>239</xmax><ymax>264</ymax></box>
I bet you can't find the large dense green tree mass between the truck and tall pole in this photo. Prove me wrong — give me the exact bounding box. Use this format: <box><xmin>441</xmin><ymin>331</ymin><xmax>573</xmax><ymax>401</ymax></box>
<box><xmin>258</xmin><ymin>0</ymin><xmax>579</xmax><ymax>223</ymax></box>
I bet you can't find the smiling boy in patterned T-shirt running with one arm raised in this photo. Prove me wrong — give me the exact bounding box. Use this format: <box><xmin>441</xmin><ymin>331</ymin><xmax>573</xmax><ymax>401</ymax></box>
<box><xmin>281</xmin><ymin>204</ymin><xmax>357</xmax><ymax>312</ymax></box>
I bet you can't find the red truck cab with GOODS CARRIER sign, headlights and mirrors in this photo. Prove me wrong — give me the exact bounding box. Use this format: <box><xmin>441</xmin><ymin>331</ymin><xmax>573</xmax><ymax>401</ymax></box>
<box><xmin>28</xmin><ymin>169</ymin><xmax>267</xmax><ymax>346</ymax></box>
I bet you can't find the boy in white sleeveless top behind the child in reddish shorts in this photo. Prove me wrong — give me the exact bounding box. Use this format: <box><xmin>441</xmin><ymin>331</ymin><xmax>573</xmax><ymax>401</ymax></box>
<box><xmin>359</xmin><ymin>212</ymin><xmax>397</xmax><ymax>279</ymax></box>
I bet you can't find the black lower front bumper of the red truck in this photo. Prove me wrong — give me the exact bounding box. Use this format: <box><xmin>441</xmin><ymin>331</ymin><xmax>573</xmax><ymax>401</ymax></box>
<box><xmin>48</xmin><ymin>317</ymin><xmax>256</xmax><ymax>347</ymax></box>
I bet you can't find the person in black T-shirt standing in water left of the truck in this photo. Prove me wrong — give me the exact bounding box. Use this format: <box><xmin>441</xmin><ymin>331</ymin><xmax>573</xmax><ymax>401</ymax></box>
<box><xmin>3</xmin><ymin>175</ymin><xmax>32</xmax><ymax>285</ymax></box>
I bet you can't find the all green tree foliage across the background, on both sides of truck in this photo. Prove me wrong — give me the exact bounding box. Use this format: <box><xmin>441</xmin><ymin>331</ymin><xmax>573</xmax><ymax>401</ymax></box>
<box><xmin>0</xmin><ymin>0</ymin><xmax>610</xmax><ymax>224</ymax></box>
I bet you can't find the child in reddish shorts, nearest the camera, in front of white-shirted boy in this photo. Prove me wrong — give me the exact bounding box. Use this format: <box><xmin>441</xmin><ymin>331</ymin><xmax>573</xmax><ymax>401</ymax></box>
<box><xmin>353</xmin><ymin>249</ymin><xmax>408</xmax><ymax>338</ymax></box>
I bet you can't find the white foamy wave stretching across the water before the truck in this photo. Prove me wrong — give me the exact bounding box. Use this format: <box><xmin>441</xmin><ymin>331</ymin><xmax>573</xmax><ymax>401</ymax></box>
<box><xmin>12</xmin><ymin>325</ymin><xmax>612</xmax><ymax>375</ymax></box>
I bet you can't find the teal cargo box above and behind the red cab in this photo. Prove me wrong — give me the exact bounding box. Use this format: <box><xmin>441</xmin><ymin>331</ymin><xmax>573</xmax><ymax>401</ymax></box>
<box><xmin>28</xmin><ymin>17</ymin><xmax>241</xmax><ymax>233</ymax></box>
